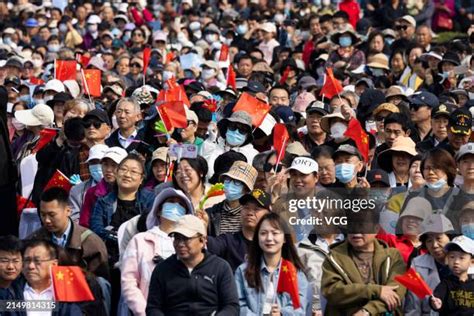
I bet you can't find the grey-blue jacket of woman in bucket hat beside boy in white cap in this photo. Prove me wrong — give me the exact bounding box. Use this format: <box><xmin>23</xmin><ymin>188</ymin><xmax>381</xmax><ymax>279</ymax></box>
<box><xmin>404</xmin><ymin>254</ymin><xmax>441</xmax><ymax>316</ymax></box>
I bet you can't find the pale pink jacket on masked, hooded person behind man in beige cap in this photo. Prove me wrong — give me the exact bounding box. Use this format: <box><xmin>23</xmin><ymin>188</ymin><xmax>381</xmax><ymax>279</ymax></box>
<box><xmin>121</xmin><ymin>226</ymin><xmax>174</xmax><ymax>316</ymax></box>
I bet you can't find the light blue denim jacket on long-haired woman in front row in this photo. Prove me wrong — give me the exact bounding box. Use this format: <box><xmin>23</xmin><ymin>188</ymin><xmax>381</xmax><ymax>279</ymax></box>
<box><xmin>235</xmin><ymin>260</ymin><xmax>311</xmax><ymax>316</ymax></box>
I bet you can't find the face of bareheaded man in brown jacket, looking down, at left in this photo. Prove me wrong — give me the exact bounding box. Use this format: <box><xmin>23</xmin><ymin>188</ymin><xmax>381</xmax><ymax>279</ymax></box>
<box><xmin>40</xmin><ymin>200</ymin><xmax>71</xmax><ymax>234</ymax></box>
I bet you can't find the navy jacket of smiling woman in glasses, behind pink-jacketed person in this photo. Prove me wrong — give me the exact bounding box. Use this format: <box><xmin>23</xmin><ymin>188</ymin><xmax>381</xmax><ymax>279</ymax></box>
<box><xmin>90</xmin><ymin>189</ymin><xmax>155</xmax><ymax>240</ymax></box>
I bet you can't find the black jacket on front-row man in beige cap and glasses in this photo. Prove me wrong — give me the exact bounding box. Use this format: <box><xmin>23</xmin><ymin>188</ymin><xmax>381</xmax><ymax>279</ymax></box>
<box><xmin>146</xmin><ymin>252</ymin><xmax>239</xmax><ymax>316</ymax></box>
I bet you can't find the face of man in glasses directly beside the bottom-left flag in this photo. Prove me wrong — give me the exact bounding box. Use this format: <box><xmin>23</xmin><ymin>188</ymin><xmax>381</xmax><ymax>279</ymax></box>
<box><xmin>23</xmin><ymin>246</ymin><xmax>58</xmax><ymax>287</ymax></box>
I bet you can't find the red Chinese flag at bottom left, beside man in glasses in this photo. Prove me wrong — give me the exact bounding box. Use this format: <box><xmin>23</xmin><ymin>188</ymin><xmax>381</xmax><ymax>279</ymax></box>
<box><xmin>51</xmin><ymin>266</ymin><xmax>95</xmax><ymax>302</ymax></box>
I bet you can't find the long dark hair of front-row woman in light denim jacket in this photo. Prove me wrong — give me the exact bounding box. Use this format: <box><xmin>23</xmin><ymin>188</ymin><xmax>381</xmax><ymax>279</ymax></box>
<box><xmin>245</xmin><ymin>213</ymin><xmax>304</xmax><ymax>291</ymax></box>
